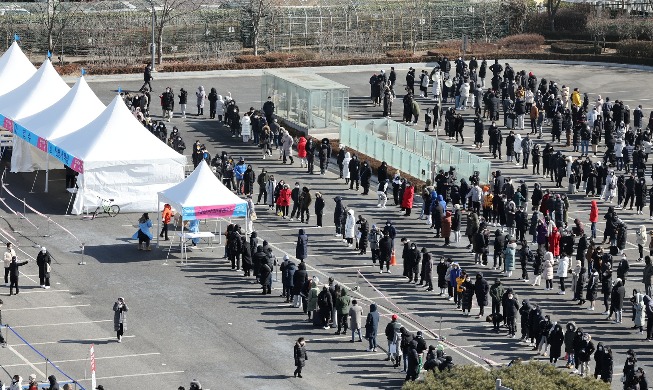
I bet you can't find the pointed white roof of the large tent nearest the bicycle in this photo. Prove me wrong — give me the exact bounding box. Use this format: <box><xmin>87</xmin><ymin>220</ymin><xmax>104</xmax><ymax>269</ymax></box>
<box><xmin>47</xmin><ymin>95</ymin><xmax>186</xmax><ymax>171</ymax></box>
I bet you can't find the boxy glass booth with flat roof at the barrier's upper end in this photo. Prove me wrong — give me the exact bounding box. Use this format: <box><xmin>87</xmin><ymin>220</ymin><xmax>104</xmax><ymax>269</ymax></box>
<box><xmin>261</xmin><ymin>69</ymin><xmax>349</xmax><ymax>134</ymax></box>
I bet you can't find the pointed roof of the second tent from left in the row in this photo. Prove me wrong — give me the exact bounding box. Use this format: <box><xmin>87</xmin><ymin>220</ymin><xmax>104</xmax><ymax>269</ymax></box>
<box><xmin>0</xmin><ymin>60</ymin><xmax>70</xmax><ymax>121</ymax></box>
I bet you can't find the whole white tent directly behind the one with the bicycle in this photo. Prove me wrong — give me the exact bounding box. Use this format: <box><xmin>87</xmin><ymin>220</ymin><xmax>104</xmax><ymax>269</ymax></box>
<box><xmin>11</xmin><ymin>76</ymin><xmax>105</xmax><ymax>192</ymax></box>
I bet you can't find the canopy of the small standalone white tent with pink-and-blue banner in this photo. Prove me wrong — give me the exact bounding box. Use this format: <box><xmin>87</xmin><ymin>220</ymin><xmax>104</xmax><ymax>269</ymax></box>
<box><xmin>159</xmin><ymin>160</ymin><xmax>247</xmax><ymax>220</ymax></box>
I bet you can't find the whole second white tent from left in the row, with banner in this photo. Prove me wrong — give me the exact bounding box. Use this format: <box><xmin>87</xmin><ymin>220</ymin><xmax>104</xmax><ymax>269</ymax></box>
<box><xmin>0</xmin><ymin>60</ymin><xmax>70</xmax><ymax>172</ymax></box>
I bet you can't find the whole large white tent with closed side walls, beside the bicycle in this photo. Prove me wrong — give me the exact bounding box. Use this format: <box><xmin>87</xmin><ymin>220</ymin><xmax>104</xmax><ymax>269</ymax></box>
<box><xmin>48</xmin><ymin>96</ymin><xmax>186</xmax><ymax>214</ymax></box>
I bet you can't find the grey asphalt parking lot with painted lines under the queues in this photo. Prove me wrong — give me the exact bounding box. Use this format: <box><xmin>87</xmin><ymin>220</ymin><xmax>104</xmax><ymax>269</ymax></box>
<box><xmin>0</xmin><ymin>61</ymin><xmax>653</xmax><ymax>390</ymax></box>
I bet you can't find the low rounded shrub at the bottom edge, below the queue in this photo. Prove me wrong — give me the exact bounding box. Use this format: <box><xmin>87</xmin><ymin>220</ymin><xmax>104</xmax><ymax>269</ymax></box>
<box><xmin>403</xmin><ymin>362</ymin><xmax>610</xmax><ymax>390</ymax></box>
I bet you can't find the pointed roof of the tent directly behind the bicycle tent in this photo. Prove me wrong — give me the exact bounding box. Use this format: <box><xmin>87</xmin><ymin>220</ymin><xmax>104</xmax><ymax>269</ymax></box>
<box><xmin>18</xmin><ymin>76</ymin><xmax>106</xmax><ymax>140</ymax></box>
